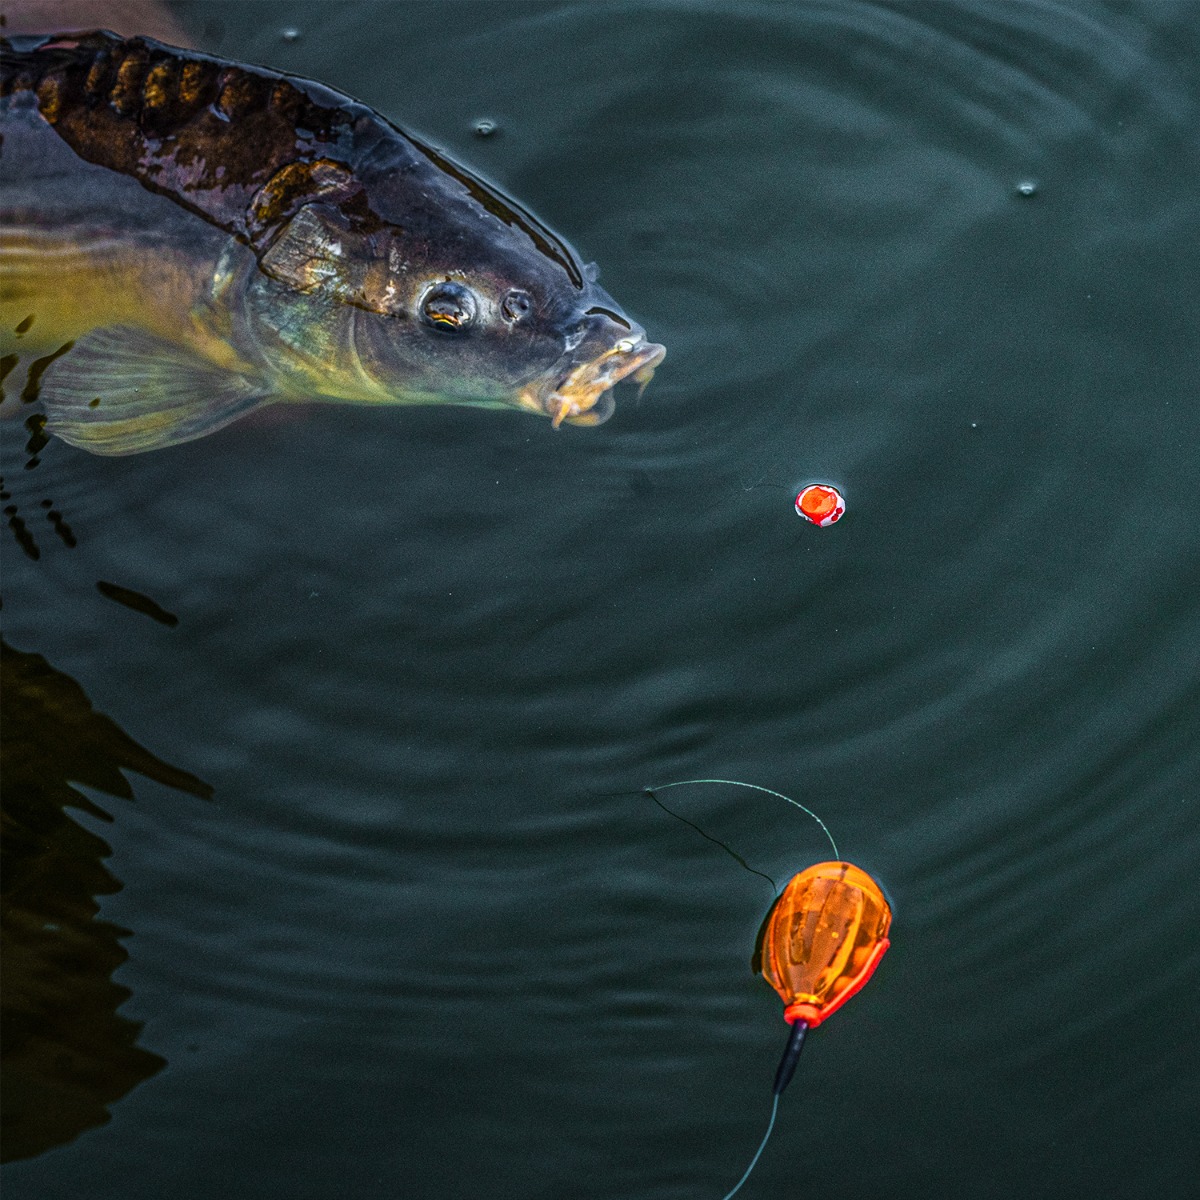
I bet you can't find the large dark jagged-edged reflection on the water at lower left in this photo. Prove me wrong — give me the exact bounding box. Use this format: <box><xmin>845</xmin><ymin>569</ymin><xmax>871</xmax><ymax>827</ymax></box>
<box><xmin>0</xmin><ymin>642</ymin><xmax>211</xmax><ymax>1162</ymax></box>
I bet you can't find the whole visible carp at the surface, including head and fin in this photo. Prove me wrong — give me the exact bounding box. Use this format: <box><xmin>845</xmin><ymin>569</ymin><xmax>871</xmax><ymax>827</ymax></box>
<box><xmin>0</xmin><ymin>31</ymin><xmax>666</xmax><ymax>455</ymax></box>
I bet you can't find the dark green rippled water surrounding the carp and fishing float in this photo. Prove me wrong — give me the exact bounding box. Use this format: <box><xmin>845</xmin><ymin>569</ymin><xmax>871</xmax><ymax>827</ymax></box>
<box><xmin>4</xmin><ymin>0</ymin><xmax>1200</xmax><ymax>1200</ymax></box>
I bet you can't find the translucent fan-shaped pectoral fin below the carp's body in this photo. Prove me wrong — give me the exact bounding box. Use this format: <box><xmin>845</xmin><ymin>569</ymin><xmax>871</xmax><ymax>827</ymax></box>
<box><xmin>40</xmin><ymin>325</ymin><xmax>271</xmax><ymax>455</ymax></box>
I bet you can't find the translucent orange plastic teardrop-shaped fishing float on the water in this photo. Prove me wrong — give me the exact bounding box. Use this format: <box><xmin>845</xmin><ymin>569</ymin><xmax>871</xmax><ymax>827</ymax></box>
<box><xmin>761</xmin><ymin>863</ymin><xmax>892</xmax><ymax>1027</ymax></box>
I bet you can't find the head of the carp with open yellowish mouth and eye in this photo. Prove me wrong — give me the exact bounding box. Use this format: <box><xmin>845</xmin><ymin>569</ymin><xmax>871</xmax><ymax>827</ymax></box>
<box><xmin>237</xmin><ymin>143</ymin><xmax>666</xmax><ymax>426</ymax></box>
